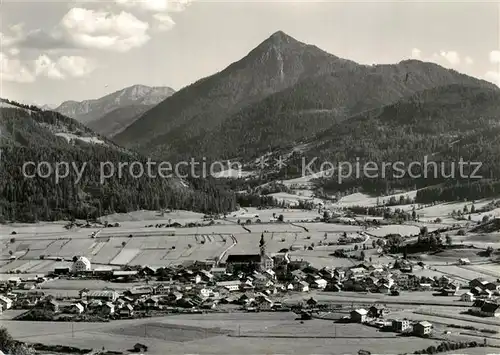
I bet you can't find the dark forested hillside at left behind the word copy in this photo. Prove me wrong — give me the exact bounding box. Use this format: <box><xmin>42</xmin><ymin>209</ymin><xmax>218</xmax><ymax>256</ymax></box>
<box><xmin>0</xmin><ymin>103</ymin><xmax>236</xmax><ymax>222</ymax></box>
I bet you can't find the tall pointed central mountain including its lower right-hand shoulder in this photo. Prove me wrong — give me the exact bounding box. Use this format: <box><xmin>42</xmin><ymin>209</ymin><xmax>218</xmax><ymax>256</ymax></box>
<box><xmin>114</xmin><ymin>31</ymin><xmax>498</xmax><ymax>160</ymax></box>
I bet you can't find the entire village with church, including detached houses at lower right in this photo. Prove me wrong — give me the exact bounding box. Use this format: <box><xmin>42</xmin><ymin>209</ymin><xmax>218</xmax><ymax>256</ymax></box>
<box><xmin>0</xmin><ymin>228</ymin><xmax>500</xmax><ymax>350</ymax></box>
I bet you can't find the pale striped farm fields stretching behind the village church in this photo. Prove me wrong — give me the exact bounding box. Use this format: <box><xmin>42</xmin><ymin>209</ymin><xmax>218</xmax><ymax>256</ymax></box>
<box><xmin>0</xmin><ymin>200</ymin><xmax>500</xmax><ymax>279</ymax></box>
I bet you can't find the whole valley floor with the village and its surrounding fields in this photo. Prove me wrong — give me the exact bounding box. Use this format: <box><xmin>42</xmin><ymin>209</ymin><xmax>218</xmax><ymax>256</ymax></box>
<box><xmin>0</xmin><ymin>196</ymin><xmax>500</xmax><ymax>353</ymax></box>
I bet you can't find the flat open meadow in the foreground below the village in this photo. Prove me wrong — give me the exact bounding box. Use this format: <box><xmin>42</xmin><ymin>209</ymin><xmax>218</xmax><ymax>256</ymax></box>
<box><xmin>4</xmin><ymin>313</ymin><xmax>437</xmax><ymax>355</ymax></box>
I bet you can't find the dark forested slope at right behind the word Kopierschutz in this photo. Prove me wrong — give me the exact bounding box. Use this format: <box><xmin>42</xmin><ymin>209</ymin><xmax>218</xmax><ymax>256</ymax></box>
<box><xmin>288</xmin><ymin>85</ymin><xmax>500</xmax><ymax>202</ymax></box>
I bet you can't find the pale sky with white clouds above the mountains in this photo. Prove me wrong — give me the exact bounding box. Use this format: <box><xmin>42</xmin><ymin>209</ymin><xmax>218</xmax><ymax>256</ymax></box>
<box><xmin>0</xmin><ymin>0</ymin><xmax>500</xmax><ymax>106</ymax></box>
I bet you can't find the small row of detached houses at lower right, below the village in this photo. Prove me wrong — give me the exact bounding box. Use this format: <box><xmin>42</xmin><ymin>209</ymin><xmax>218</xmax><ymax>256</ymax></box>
<box><xmin>350</xmin><ymin>306</ymin><xmax>433</xmax><ymax>337</ymax></box>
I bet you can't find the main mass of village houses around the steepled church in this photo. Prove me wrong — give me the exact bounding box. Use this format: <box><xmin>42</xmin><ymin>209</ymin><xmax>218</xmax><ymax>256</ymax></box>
<box><xmin>0</xmin><ymin>236</ymin><xmax>500</xmax><ymax>324</ymax></box>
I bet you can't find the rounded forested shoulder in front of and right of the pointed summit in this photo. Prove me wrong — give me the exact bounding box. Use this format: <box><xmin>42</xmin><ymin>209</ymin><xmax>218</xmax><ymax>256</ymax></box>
<box><xmin>171</xmin><ymin>61</ymin><xmax>494</xmax><ymax>161</ymax></box>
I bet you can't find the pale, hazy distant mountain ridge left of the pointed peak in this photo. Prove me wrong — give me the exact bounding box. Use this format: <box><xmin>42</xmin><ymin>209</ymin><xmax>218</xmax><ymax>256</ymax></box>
<box><xmin>54</xmin><ymin>85</ymin><xmax>175</xmax><ymax>123</ymax></box>
